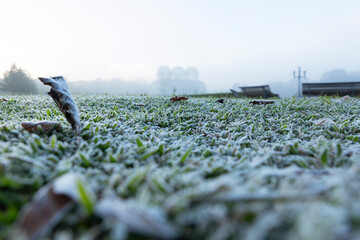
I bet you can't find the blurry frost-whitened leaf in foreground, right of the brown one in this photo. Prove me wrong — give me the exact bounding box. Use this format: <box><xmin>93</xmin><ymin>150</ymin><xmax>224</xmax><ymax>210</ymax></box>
<box><xmin>96</xmin><ymin>198</ymin><xmax>178</xmax><ymax>239</ymax></box>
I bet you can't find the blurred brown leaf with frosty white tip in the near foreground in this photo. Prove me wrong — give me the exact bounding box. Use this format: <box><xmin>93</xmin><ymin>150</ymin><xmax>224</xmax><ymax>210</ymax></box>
<box><xmin>16</xmin><ymin>173</ymin><xmax>79</xmax><ymax>239</ymax></box>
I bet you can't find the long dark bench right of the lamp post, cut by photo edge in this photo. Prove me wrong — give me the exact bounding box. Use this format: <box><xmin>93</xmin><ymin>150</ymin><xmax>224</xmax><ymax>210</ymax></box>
<box><xmin>302</xmin><ymin>82</ymin><xmax>360</xmax><ymax>97</ymax></box>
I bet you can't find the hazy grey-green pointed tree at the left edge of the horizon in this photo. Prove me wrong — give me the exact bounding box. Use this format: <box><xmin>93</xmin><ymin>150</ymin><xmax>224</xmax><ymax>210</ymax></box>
<box><xmin>0</xmin><ymin>64</ymin><xmax>37</xmax><ymax>94</ymax></box>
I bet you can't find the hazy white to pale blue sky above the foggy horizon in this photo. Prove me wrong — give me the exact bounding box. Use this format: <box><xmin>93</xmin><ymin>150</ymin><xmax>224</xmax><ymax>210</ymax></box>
<box><xmin>0</xmin><ymin>0</ymin><xmax>360</xmax><ymax>90</ymax></box>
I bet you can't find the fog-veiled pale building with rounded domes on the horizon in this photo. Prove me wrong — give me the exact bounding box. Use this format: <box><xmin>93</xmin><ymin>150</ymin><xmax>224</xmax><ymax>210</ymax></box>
<box><xmin>152</xmin><ymin>66</ymin><xmax>206</xmax><ymax>95</ymax></box>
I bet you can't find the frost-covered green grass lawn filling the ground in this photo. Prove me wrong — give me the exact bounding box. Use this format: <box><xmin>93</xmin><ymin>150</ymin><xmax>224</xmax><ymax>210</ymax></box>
<box><xmin>0</xmin><ymin>95</ymin><xmax>360</xmax><ymax>239</ymax></box>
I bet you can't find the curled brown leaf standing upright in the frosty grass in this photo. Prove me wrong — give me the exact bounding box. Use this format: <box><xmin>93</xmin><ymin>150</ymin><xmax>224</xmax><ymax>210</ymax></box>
<box><xmin>39</xmin><ymin>76</ymin><xmax>82</xmax><ymax>134</ymax></box>
